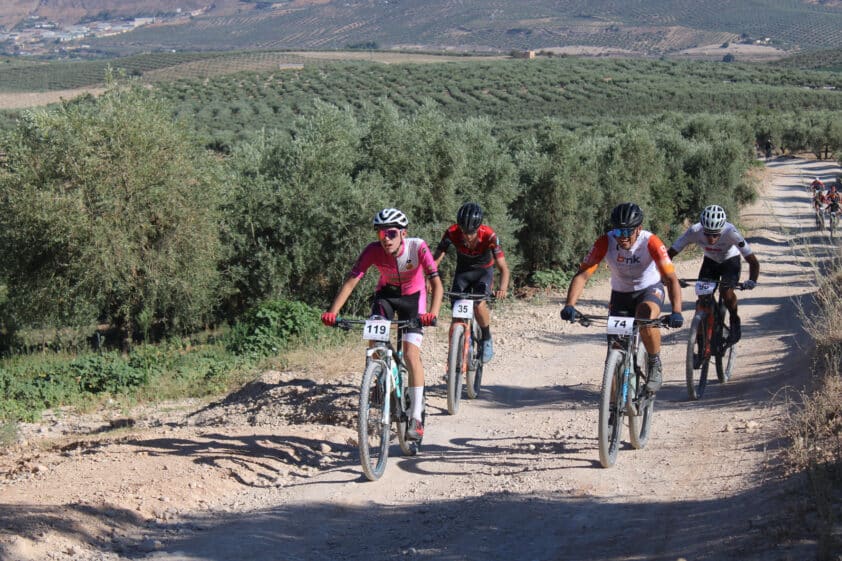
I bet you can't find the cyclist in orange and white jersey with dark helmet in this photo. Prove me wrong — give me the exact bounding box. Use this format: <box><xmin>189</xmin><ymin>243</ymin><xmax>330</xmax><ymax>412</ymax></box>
<box><xmin>561</xmin><ymin>203</ymin><xmax>684</xmax><ymax>393</ymax></box>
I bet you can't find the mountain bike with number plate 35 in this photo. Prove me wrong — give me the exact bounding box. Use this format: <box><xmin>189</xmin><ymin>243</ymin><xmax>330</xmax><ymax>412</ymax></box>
<box><xmin>445</xmin><ymin>292</ymin><xmax>491</xmax><ymax>415</ymax></box>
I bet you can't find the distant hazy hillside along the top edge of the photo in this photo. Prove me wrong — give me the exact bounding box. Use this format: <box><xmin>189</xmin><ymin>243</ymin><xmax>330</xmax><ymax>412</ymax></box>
<box><xmin>0</xmin><ymin>0</ymin><xmax>842</xmax><ymax>56</ymax></box>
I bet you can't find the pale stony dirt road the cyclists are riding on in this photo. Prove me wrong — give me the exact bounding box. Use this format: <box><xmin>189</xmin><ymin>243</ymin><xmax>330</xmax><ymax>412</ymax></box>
<box><xmin>0</xmin><ymin>156</ymin><xmax>835</xmax><ymax>561</ymax></box>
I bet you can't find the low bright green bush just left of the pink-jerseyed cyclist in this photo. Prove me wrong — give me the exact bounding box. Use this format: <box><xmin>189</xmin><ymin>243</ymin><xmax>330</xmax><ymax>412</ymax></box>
<box><xmin>227</xmin><ymin>300</ymin><xmax>322</xmax><ymax>356</ymax></box>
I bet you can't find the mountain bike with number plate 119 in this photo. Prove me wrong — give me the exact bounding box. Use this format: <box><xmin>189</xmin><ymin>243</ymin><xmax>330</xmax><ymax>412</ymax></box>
<box><xmin>336</xmin><ymin>316</ymin><xmax>425</xmax><ymax>481</ymax></box>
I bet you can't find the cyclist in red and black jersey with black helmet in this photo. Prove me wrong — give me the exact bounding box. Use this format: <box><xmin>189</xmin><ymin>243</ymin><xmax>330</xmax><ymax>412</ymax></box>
<box><xmin>433</xmin><ymin>203</ymin><xmax>509</xmax><ymax>363</ymax></box>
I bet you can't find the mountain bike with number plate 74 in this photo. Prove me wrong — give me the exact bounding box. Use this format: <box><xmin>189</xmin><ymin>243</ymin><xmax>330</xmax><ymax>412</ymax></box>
<box><xmin>576</xmin><ymin>311</ymin><xmax>669</xmax><ymax>468</ymax></box>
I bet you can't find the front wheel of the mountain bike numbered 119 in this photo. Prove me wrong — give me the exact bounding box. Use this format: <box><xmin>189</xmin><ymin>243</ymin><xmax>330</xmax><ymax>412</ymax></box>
<box><xmin>357</xmin><ymin>360</ymin><xmax>391</xmax><ymax>481</ymax></box>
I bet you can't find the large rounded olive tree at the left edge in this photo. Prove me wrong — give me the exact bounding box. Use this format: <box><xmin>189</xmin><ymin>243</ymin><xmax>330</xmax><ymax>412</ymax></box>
<box><xmin>0</xmin><ymin>82</ymin><xmax>222</xmax><ymax>343</ymax></box>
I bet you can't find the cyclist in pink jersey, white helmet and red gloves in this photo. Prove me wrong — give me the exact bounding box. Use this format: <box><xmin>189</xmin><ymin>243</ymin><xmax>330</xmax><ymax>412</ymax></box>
<box><xmin>322</xmin><ymin>208</ymin><xmax>444</xmax><ymax>440</ymax></box>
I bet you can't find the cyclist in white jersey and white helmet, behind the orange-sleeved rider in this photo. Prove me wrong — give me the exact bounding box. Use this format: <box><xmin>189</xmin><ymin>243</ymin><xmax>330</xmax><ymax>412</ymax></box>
<box><xmin>669</xmin><ymin>205</ymin><xmax>760</xmax><ymax>344</ymax></box>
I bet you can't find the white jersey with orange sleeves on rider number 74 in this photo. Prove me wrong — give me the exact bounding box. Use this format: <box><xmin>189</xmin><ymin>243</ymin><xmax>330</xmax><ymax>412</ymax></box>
<box><xmin>579</xmin><ymin>230</ymin><xmax>675</xmax><ymax>292</ymax></box>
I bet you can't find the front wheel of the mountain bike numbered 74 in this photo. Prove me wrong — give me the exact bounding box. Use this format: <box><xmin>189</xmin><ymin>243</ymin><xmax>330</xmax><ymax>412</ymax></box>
<box><xmin>599</xmin><ymin>349</ymin><xmax>625</xmax><ymax>468</ymax></box>
